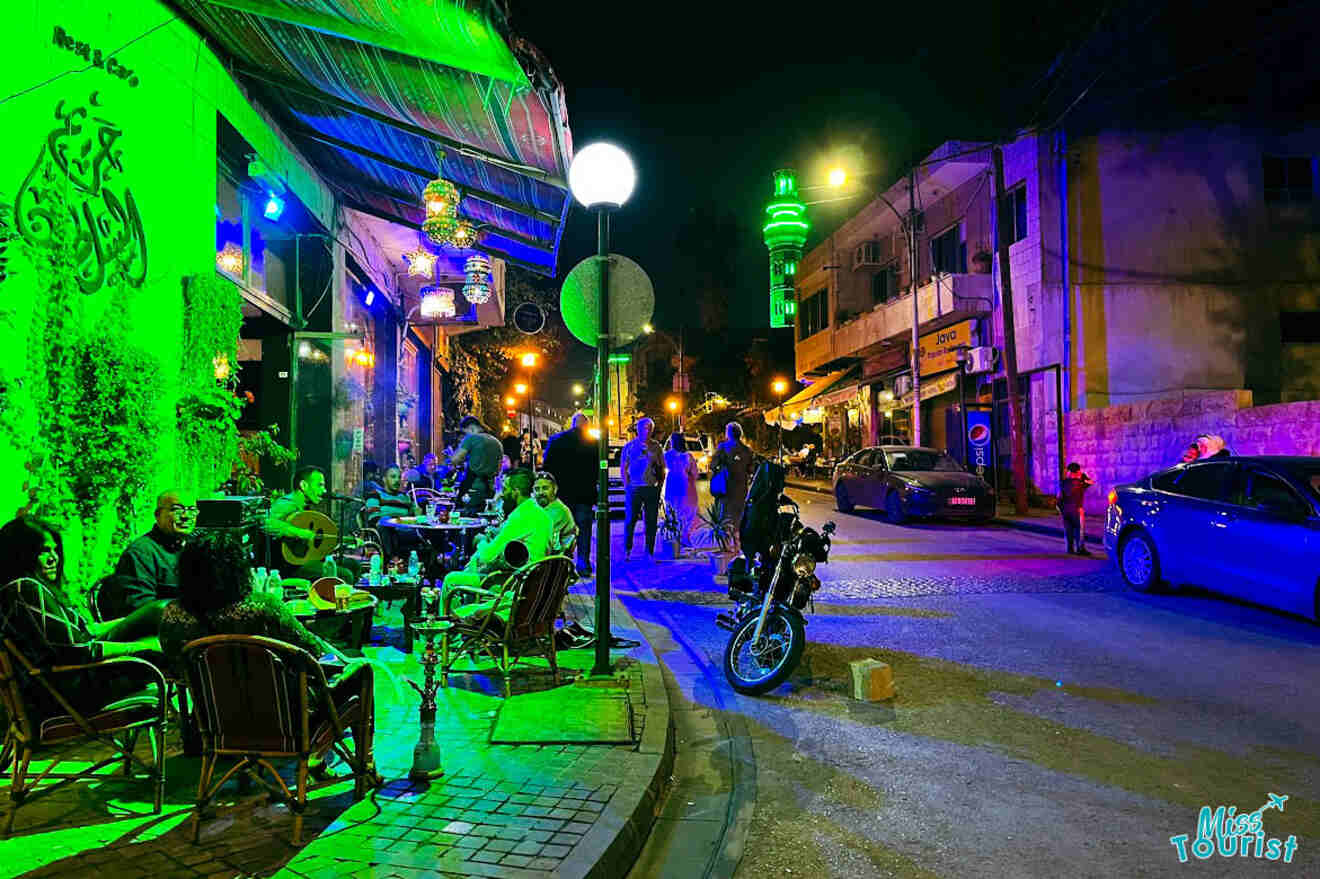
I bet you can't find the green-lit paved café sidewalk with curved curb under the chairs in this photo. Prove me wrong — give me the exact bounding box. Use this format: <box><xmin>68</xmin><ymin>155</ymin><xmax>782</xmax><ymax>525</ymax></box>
<box><xmin>0</xmin><ymin>562</ymin><xmax>673</xmax><ymax>879</ymax></box>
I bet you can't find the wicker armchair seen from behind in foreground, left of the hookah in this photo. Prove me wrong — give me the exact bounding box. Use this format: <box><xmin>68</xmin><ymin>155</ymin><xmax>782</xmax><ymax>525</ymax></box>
<box><xmin>182</xmin><ymin>635</ymin><xmax>380</xmax><ymax>846</ymax></box>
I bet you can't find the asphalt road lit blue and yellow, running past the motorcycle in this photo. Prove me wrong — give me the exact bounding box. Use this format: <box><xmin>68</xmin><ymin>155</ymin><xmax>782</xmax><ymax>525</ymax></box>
<box><xmin>615</xmin><ymin>492</ymin><xmax>1320</xmax><ymax>879</ymax></box>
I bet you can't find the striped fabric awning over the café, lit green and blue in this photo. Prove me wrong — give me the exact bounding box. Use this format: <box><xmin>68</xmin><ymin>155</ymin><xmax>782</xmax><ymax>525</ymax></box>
<box><xmin>174</xmin><ymin>0</ymin><xmax>573</xmax><ymax>275</ymax></box>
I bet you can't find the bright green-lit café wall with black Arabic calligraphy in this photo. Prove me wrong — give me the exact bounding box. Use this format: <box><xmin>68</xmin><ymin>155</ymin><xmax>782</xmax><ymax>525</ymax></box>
<box><xmin>0</xmin><ymin>0</ymin><xmax>334</xmax><ymax>585</ymax></box>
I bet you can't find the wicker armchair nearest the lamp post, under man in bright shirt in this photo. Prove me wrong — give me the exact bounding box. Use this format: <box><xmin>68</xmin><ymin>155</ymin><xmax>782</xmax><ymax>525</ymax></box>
<box><xmin>440</xmin><ymin>556</ymin><xmax>577</xmax><ymax>698</ymax></box>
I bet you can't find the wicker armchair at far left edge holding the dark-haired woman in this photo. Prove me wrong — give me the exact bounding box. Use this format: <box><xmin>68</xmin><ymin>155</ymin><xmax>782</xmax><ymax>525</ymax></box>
<box><xmin>0</xmin><ymin>637</ymin><xmax>165</xmax><ymax>837</ymax></box>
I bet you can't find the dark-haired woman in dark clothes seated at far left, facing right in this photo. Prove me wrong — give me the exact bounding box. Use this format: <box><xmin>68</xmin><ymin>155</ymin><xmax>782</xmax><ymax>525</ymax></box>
<box><xmin>0</xmin><ymin>519</ymin><xmax>160</xmax><ymax>717</ymax></box>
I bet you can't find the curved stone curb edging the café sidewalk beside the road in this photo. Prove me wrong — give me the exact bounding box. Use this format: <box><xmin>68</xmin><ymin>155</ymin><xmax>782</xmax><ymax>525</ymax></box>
<box><xmin>554</xmin><ymin>588</ymin><xmax>675</xmax><ymax>879</ymax></box>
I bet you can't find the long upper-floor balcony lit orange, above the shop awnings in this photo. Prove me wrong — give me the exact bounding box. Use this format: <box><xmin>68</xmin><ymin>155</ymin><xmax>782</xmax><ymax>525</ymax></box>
<box><xmin>796</xmin><ymin>275</ymin><xmax>994</xmax><ymax>379</ymax></box>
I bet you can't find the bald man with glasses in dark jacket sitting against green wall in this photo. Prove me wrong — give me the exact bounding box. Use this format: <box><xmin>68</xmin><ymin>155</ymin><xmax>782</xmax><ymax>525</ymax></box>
<box><xmin>98</xmin><ymin>491</ymin><xmax>197</xmax><ymax>619</ymax></box>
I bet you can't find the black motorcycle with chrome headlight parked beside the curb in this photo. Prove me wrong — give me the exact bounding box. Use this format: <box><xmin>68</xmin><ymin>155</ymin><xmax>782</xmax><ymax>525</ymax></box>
<box><xmin>715</xmin><ymin>461</ymin><xmax>834</xmax><ymax>696</ymax></box>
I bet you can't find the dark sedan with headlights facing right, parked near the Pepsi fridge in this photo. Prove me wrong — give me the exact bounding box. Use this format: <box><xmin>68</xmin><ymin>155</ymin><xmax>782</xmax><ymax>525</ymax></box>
<box><xmin>834</xmin><ymin>446</ymin><xmax>994</xmax><ymax>524</ymax></box>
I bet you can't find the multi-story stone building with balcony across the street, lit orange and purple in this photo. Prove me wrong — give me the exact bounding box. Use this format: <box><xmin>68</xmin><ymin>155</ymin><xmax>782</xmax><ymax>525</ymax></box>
<box><xmin>788</xmin><ymin>125</ymin><xmax>1320</xmax><ymax>494</ymax></box>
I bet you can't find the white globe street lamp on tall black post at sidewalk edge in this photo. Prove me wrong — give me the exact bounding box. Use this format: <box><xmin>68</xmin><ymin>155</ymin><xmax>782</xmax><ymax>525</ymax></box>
<box><xmin>569</xmin><ymin>143</ymin><xmax>638</xmax><ymax>674</ymax></box>
